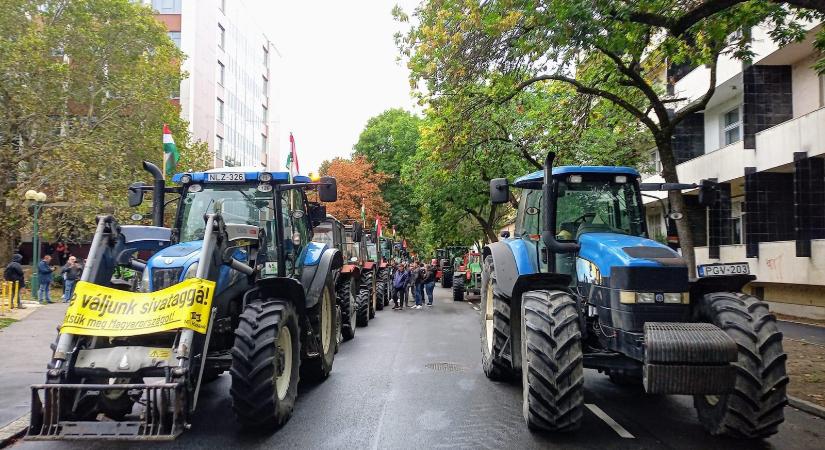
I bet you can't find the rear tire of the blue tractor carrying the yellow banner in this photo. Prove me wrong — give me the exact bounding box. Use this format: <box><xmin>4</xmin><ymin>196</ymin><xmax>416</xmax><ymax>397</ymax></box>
<box><xmin>301</xmin><ymin>283</ymin><xmax>336</xmax><ymax>382</ymax></box>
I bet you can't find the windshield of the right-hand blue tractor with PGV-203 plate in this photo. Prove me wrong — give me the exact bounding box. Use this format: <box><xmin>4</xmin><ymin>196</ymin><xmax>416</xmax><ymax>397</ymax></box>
<box><xmin>556</xmin><ymin>175</ymin><xmax>644</xmax><ymax>240</ymax></box>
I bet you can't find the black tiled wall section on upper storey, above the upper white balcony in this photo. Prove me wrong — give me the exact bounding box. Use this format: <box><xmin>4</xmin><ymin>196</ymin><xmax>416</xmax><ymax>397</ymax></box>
<box><xmin>742</xmin><ymin>66</ymin><xmax>793</xmax><ymax>149</ymax></box>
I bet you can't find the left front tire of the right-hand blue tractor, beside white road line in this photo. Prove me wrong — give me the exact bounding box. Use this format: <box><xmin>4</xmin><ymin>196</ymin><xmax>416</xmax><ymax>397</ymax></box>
<box><xmin>521</xmin><ymin>290</ymin><xmax>584</xmax><ymax>431</ymax></box>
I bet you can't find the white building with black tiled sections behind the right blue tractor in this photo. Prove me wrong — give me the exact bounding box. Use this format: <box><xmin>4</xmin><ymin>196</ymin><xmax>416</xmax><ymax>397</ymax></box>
<box><xmin>645</xmin><ymin>24</ymin><xmax>825</xmax><ymax>318</ymax></box>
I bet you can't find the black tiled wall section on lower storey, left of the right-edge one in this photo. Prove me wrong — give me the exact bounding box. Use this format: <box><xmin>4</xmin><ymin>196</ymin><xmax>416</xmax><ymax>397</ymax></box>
<box><xmin>745</xmin><ymin>167</ymin><xmax>796</xmax><ymax>258</ymax></box>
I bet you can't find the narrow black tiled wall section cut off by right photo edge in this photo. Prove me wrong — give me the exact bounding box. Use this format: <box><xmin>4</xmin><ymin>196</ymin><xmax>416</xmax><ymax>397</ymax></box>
<box><xmin>793</xmin><ymin>153</ymin><xmax>825</xmax><ymax>257</ymax></box>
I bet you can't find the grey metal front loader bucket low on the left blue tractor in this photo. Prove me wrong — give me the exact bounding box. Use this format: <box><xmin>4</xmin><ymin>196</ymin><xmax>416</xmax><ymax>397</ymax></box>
<box><xmin>25</xmin><ymin>383</ymin><xmax>186</xmax><ymax>441</ymax></box>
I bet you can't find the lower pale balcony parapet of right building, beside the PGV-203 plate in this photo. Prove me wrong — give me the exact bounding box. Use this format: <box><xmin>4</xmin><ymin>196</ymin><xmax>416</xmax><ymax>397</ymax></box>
<box><xmin>696</xmin><ymin>239</ymin><xmax>825</xmax><ymax>286</ymax></box>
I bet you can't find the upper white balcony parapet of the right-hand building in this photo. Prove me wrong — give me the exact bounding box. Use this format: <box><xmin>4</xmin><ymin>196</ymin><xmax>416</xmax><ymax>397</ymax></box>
<box><xmin>752</xmin><ymin>108</ymin><xmax>825</xmax><ymax>171</ymax></box>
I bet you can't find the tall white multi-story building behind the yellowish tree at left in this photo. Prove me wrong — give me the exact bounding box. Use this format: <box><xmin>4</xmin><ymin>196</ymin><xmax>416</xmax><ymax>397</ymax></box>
<box><xmin>142</xmin><ymin>0</ymin><xmax>280</xmax><ymax>167</ymax></box>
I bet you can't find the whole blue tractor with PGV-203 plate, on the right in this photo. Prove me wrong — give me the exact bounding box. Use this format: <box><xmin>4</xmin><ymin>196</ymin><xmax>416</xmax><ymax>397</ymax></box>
<box><xmin>481</xmin><ymin>153</ymin><xmax>788</xmax><ymax>438</ymax></box>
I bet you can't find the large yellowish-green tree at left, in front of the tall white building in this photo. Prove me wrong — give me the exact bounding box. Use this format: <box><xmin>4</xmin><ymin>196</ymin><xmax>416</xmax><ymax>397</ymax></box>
<box><xmin>0</xmin><ymin>0</ymin><xmax>208</xmax><ymax>260</ymax></box>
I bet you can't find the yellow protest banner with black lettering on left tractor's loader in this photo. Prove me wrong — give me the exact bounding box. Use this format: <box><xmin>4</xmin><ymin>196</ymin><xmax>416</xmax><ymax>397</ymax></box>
<box><xmin>60</xmin><ymin>278</ymin><xmax>215</xmax><ymax>337</ymax></box>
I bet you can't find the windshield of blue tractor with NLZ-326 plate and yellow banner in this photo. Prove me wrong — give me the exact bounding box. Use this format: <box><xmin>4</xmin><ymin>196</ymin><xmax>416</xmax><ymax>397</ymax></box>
<box><xmin>177</xmin><ymin>185</ymin><xmax>274</xmax><ymax>242</ymax></box>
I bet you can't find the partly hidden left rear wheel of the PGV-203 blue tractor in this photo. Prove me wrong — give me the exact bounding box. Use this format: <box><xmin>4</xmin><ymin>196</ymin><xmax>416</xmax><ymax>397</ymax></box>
<box><xmin>481</xmin><ymin>256</ymin><xmax>514</xmax><ymax>381</ymax></box>
